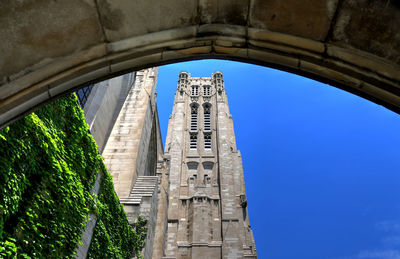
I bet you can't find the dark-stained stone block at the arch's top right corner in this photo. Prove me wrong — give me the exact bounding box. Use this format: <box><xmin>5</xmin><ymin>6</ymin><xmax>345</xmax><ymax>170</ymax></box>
<box><xmin>332</xmin><ymin>0</ymin><xmax>400</xmax><ymax>65</ymax></box>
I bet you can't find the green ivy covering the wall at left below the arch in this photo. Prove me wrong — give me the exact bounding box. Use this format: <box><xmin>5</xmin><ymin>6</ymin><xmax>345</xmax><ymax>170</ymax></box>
<box><xmin>0</xmin><ymin>94</ymin><xmax>143</xmax><ymax>258</ymax></box>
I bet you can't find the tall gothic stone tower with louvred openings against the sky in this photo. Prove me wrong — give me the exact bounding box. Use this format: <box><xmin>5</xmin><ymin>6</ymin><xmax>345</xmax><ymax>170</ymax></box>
<box><xmin>159</xmin><ymin>72</ymin><xmax>257</xmax><ymax>258</ymax></box>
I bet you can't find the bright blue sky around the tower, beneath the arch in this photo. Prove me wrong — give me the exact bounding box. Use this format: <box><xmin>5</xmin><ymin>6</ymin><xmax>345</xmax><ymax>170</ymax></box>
<box><xmin>157</xmin><ymin>60</ymin><xmax>400</xmax><ymax>259</ymax></box>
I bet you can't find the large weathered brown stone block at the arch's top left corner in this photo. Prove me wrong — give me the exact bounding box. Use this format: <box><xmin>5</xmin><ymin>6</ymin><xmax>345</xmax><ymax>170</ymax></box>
<box><xmin>0</xmin><ymin>0</ymin><xmax>104</xmax><ymax>78</ymax></box>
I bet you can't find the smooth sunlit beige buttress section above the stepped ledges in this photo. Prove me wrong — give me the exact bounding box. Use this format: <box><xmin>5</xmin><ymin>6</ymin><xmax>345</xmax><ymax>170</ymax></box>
<box><xmin>103</xmin><ymin>68</ymin><xmax>158</xmax><ymax>198</ymax></box>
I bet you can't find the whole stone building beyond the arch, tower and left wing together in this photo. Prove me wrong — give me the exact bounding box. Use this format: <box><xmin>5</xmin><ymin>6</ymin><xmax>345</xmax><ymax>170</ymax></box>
<box><xmin>77</xmin><ymin>68</ymin><xmax>257</xmax><ymax>259</ymax></box>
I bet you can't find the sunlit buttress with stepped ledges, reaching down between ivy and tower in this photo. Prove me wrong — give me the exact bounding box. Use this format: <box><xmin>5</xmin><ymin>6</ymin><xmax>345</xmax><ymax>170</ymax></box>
<box><xmin>103</xmin><ymin>68</ymin><xmax>163</xmax><ymax>259</ymax></box>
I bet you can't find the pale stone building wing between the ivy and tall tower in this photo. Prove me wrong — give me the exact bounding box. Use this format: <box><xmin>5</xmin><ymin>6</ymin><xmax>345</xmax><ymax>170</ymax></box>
<box><xmin>76</xmin><ymin>68</ymin><xmax>163</xmax><ymax>259</ymax></box>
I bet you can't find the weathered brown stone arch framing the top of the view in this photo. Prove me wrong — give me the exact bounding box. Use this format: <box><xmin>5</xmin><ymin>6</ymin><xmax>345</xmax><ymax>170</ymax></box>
<box><xmin>0</xmin><ymin>0</ymin><xmax>400</xmax><ymax>127</ymax></box>
